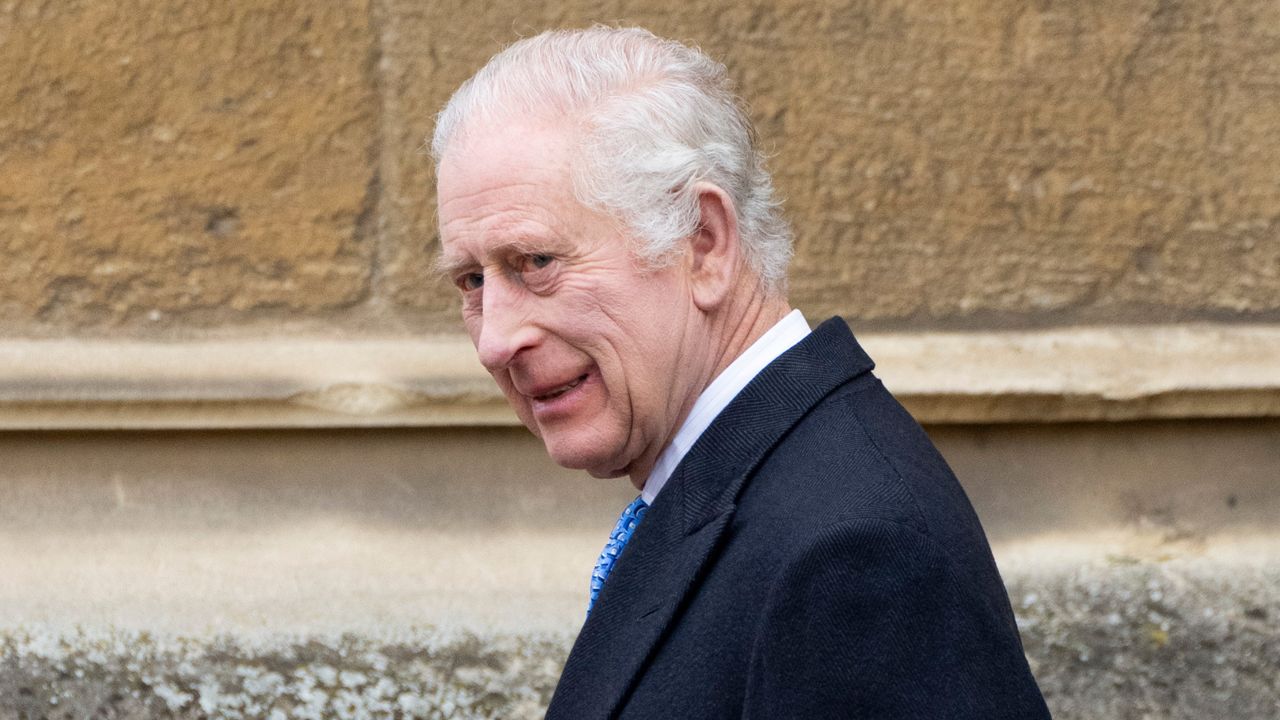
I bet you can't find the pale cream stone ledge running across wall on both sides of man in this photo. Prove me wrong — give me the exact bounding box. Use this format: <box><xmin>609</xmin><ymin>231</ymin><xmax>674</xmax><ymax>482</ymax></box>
<box><xmin>0</xmin><ymin>325</ymin><xmax>1280</xmax><ymax>429</ymax></box>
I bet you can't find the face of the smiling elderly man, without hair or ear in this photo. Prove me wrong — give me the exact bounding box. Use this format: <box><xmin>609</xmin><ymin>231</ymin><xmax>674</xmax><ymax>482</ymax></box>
<box><xmin>438</xmin><ymin>126</ymin><xmax>703</xmax><ymax>483</ymax></box>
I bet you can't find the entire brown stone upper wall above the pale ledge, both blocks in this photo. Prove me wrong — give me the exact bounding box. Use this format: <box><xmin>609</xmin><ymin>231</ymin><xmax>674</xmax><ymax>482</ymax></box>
<box><xmin>0</xmin><ymin>0</ymin><xmax>1280</xmax><ymax>337</ymax></box>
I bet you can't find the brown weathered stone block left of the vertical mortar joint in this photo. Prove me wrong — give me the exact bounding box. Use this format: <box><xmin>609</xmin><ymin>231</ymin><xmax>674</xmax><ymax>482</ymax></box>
<box><xmin>0</xmin><ymin>0</ymin><xmax>378</xmax><ymax>334</ymax></box>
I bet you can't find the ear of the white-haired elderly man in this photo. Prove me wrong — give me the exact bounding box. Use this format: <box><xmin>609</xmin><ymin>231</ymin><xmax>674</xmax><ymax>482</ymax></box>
<box><xmin>689</xmin><ymin>182</ymin><xmax>742</xmax><ymax>313</ymax></box>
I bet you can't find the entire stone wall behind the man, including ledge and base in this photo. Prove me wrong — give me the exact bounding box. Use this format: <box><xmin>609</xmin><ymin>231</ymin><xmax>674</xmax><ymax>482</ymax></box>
<box><xmin>0</xmin><ymin>0</ymin><xmax>1280</xmax><ymax>720</ymax></box>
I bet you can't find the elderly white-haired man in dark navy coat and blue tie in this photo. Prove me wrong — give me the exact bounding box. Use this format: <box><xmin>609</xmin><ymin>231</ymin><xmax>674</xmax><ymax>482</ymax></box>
<box><xmin>433</xmin><ymin>27</ymin><xmax>1048</xmax><ymax>720</ymax></box>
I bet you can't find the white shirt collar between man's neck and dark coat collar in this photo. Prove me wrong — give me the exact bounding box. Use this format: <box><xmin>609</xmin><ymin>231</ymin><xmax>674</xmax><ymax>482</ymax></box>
<box><xmin>640</xmin><ymin>310</ymin><xmax>809</xmax><ymax>505</ymax></box>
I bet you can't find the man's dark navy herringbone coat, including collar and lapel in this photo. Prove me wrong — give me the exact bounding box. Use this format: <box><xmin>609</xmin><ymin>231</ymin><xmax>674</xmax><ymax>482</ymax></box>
<box><xmin>547</xmin><ymin>319</ymin><xmax>1050</xmax><ymax>720</ymax></box>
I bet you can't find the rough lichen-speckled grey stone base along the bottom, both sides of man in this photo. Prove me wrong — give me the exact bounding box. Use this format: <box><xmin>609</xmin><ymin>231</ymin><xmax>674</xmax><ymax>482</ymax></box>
<box><xmin>0</xmin><ymin>555</ymin><xmax>1280</xmax><ymax>720</ymax></box>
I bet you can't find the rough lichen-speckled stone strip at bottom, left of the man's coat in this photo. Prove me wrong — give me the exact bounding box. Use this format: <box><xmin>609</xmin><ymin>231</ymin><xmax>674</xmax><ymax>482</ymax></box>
<box><xmin>0</xmin><ymin>629</ymin><xmax>567</xmax><ymax>720</ymax></box>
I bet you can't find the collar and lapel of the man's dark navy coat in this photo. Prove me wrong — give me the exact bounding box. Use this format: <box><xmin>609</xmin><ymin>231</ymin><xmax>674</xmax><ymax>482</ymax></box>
<box><xmin>547</xmin><ymin>318</ymin><xmax>873</xmax><ymax>720</ymax></box>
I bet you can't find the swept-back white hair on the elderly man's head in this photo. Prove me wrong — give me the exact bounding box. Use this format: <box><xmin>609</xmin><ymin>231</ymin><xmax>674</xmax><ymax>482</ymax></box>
<box><xmin>431</xmin><ymin>26</ymin><xmax>791</xmax><ymax>291</ymax></box>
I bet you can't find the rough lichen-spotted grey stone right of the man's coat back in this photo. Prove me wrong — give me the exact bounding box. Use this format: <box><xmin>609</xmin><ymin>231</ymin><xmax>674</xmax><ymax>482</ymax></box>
<box><xmin>1005</xmin><ymin>551</ymin><xmax>1280</xmax><ymax>720</ymax></box>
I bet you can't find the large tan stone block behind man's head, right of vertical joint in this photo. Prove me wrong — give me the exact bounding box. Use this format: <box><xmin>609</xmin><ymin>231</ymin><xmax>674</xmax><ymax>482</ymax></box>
<box><xmin>383</xmin><ymin>0</ymin><xmax>1280</xmax><ymax>328</ymax></box>
